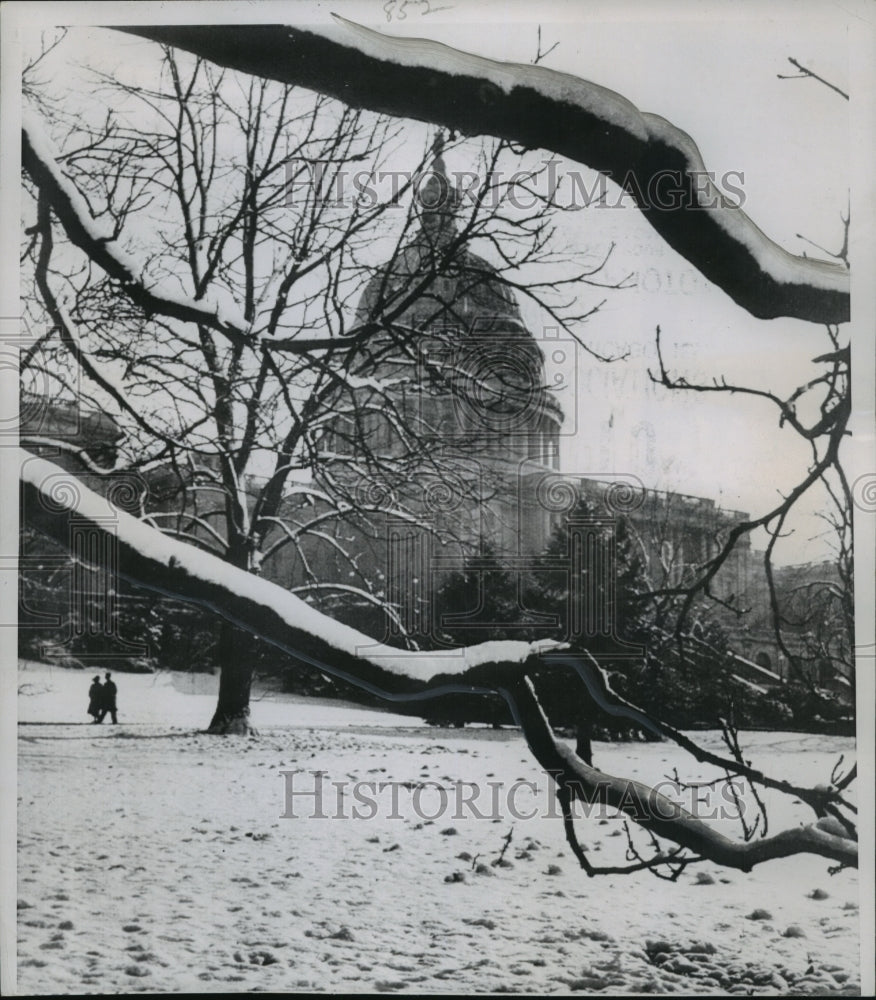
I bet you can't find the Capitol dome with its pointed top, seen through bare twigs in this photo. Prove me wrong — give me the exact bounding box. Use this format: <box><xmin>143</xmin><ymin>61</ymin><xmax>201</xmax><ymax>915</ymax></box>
<box><xmin>348</xmin><ymin>137</ymin><xmax>563</xmax><ymax>460</ymax></box>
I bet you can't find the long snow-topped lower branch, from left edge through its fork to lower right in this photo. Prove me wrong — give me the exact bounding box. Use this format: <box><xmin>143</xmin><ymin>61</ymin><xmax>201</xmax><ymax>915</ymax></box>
<box><xmin>20</xmin><ymin>451</ymin><xmax>857</xmax><ymax>875</ymax></box>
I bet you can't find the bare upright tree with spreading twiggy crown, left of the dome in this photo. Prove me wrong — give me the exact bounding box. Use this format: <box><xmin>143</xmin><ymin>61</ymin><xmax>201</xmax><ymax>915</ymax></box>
<box><xmin>22</xmin><ymin>35</ymin><xmax>622</xmax><ymax>732</ymax></box>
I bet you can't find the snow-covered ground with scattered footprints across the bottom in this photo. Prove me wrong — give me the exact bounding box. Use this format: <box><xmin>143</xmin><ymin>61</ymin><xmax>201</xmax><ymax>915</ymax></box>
<box><xmin>18</xmin><ymin>664</ymin><xmax>859</xmax><ymax>995</ymax></box>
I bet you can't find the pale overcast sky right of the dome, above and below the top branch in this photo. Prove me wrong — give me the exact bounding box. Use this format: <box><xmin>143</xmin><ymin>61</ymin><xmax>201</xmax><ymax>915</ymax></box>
<box><xmin>10</xmin><ymin>0</ymin><xmax>850</xmax><ymax>562</ymax></box>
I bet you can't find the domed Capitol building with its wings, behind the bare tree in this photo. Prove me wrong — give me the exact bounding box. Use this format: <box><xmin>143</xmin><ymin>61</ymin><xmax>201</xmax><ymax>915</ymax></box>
<box><xmin>22</xmin><ymin>137</ymin><xmax>848</xmax><ymax>687</ymax></box>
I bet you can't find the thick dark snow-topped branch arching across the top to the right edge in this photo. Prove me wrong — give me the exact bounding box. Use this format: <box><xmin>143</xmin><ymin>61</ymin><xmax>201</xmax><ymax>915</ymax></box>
<box><xmin>118</xmin><ymin>17</ymin><xmax>849</xmax><ymax>323</ymax></box>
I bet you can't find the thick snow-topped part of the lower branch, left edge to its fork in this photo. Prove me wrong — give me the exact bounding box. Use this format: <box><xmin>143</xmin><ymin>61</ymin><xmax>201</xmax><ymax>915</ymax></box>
<box><xmin>21</xmin><ymin>451</ymin><xmax>559</xmax><ymax>688</ymax></box>
